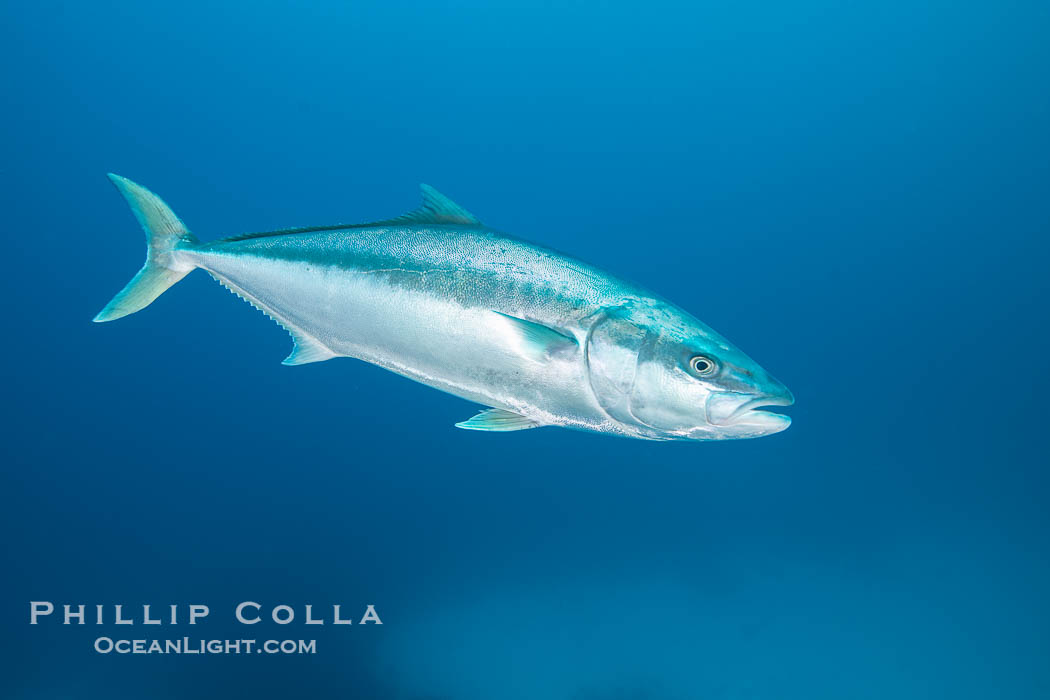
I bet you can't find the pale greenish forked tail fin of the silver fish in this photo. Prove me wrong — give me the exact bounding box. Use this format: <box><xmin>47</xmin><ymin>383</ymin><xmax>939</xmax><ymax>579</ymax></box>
<box><xmin>95</xmin><ymin>173</ymin><xmax>197</xmax><ymax>323</ymax></box>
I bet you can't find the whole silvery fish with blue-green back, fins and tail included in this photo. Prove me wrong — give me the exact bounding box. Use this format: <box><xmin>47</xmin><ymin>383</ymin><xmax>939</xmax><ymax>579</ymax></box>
<box><xmin>97</xmin><ymin>176</ymin><xmax>793</xmax><ymax>440</ymax></box>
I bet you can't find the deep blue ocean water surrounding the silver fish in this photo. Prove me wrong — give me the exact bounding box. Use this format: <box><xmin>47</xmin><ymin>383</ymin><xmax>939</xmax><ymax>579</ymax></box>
<box><xmin>0</xmin><ymin>0</ymin><xmax>1050</xmax><ymax>700</ymax></box>
